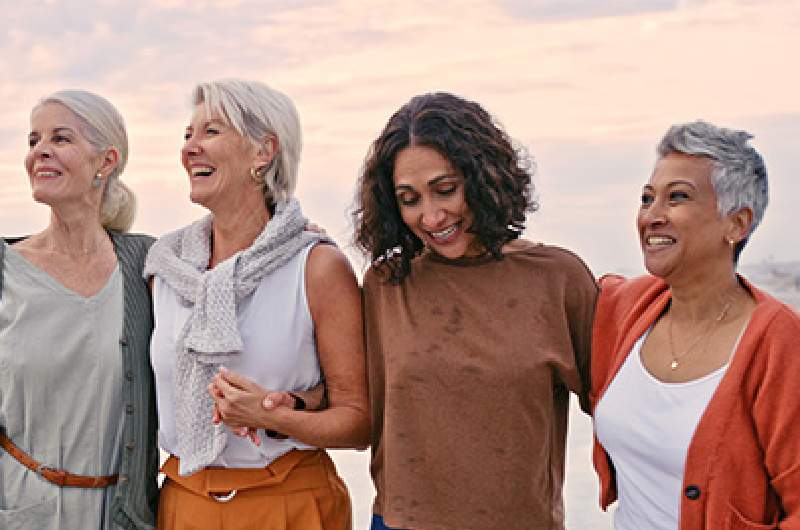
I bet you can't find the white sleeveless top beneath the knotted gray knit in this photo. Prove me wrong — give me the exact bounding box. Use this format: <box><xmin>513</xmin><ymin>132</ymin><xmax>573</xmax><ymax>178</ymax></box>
<box><xmin>150</xmin><ymin>246</ymin><xmax>320</xmax><ymax>467</ymax></box>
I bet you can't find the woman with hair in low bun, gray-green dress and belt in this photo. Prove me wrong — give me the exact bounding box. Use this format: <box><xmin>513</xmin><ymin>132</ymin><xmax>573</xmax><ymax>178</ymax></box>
<box><xmin>0</xmin><ymin>90</ymin><xmax>158</xmax><ymax>530</ymax></box>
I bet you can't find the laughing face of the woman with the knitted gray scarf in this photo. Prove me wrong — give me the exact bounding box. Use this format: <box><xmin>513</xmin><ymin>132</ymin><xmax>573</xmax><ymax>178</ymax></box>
<box><xmin>181</xmin><ymin>104</ymin><xmax>265</xmax><ymax>211</ymax></box>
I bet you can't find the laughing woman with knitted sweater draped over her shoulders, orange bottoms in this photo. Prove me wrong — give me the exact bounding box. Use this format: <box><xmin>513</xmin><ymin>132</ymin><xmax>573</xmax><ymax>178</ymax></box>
<box><xmin>145</xmin><ymin>80</ymin><xmax>369</xmax><ymax>530</ymax></box>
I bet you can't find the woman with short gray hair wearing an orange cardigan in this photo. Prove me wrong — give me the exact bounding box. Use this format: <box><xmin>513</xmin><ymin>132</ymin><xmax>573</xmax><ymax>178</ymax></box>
<box><xmin>592</xmin><ymin>121</ymin><xmax>800</xmax><ymax>530</ymax></box>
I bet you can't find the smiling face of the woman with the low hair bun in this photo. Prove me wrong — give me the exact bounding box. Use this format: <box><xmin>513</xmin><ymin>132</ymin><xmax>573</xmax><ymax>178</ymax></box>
<box><xmin>25</xmin><ymin>103</ymin><xmax>110</xmax><ymax>208</ymax></box>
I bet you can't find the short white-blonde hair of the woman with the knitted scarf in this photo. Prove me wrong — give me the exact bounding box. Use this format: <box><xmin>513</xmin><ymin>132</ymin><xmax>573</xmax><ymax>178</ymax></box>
<box><xmin>192</xmin><ymin>79</ymin><xmax>303</xmax><ymax>206</ymax></box>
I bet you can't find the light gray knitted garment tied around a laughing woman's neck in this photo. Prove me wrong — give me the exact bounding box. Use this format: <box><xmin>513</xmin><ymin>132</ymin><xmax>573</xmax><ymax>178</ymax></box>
<box><xmin>144</xmin><ymin>199</ymin><xmax>330</xmax><ymax>475</ymax></box>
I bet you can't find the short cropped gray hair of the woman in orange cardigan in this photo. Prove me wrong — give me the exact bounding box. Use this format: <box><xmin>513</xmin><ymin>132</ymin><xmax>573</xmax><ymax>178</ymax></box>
<box><xmin>658</xmin><ymin>120</ymin><xmax>769</xmax><ymax>260</ymax></box>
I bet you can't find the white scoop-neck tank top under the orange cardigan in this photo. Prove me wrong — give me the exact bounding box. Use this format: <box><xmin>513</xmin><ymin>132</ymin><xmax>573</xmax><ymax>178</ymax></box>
<box><xmin>594</xmin><ymin>331</ymin><xmax>738</xmax><ymax>530</ymax></box>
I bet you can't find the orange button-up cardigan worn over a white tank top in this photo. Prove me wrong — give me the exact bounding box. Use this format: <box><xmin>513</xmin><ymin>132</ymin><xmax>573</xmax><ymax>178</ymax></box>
<box><xmin>590</xmin><ymin>276</ymin><xmax>800</xmax><ymax>530</ymax></box>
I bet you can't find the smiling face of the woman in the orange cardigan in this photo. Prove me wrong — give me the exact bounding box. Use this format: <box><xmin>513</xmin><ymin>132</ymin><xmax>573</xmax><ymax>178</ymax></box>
<box><xmin>637</xmin><ymin>153</ymin><xmax>743</xmax><ymax>282</ymax></box>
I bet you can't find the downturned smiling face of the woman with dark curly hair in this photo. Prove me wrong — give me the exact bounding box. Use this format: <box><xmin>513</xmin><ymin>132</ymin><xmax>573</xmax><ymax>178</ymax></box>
<box><xmin>393</xmin><ymin>146</ymin><xmax>480</xmax><ymax>259</ymax></box>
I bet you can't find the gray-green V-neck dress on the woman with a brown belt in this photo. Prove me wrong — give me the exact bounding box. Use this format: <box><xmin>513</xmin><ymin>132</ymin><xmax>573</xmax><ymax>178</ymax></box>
<box><xmin>0</xmin><ymin>242</ymin><xmax>123</xmax><ymax>530</ymax></box>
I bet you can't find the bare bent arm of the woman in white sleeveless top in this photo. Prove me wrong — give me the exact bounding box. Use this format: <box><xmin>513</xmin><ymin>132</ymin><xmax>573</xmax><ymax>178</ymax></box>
<box><xmin>211</xmin><ymin>245</ymin><xmax>369</xmax><ymax>448</ymax></box>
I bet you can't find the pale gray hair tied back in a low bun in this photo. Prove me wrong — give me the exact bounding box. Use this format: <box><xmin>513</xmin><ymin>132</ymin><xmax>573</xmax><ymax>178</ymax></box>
<box><xmin>34</xmin><ymin>90</ymin><xmax>136</xmax><ymax>232</ymax></box>
